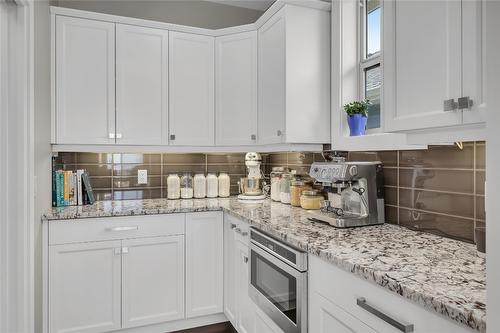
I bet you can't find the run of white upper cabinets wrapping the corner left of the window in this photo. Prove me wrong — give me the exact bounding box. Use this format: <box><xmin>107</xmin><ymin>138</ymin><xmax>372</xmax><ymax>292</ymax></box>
<box><xmin>51</xmin><ymin>1</ymin><xmax>331</xmax><ymax>151</ymax></box>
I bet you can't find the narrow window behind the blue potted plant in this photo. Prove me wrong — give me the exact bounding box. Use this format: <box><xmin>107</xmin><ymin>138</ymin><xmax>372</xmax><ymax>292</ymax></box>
<box><xmin>359</xmin><ymin>0</ymin><xmax>382</xmax><ymax>129</ymax></box>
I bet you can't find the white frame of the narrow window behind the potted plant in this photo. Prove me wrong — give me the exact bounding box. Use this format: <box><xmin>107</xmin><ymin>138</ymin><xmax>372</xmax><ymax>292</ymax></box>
<box><xmin>358</xmin><ymin>0</ymin><xmax>384</xmax><ymax>134</ymax></box>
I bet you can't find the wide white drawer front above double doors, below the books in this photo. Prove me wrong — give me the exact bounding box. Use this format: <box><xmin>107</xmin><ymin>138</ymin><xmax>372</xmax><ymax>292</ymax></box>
<box><xmin>49</xmin><ymin>214</ymin><xmax>185</xmax><ymax>245</ymax></box>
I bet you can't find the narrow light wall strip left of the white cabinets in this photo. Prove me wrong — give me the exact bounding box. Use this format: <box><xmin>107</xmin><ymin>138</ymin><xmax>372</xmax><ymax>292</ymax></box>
<box><xmin>34</xmin><ymin>0</ymin><xmax>52</xmax><ymax>332</ymax></box>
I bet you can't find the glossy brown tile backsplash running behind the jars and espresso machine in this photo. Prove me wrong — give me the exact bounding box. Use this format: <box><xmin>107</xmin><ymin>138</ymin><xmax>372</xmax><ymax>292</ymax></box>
<box><xmin>54</xmin><ymin>142</ymin><xmax>485</xmax><ymax>242</ymax></box>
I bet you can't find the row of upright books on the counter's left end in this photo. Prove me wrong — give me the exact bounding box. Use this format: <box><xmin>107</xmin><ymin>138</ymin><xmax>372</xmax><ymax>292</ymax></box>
<box><xmin>52</xmin><ymin>169</ymin><xmax>95</xmax><ymax>207</ymax></box>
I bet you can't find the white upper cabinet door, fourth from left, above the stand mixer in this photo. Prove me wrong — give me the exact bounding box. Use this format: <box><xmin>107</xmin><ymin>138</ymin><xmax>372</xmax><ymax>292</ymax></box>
<box><xmin>215</xmin><ymin>31</ymin><xmax>257</xmax><ymax>145</ymax></box>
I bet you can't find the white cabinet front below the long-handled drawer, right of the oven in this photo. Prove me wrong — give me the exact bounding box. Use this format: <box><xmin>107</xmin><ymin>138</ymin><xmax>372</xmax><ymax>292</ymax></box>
<box><xmin>309</xmin><ymin>291</ymin><xmax>376</xmax><ymax>333</ymax></box>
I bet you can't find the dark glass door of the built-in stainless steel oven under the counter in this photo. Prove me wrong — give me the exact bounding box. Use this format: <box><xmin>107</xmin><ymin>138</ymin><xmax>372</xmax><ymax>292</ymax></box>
<box><xmin>250</xmin><ymin>249</ymin><xmax>297</xmax><ymax>324</ymax></box>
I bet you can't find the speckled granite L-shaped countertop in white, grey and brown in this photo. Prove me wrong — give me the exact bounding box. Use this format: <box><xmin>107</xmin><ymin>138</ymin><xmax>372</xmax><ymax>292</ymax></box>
<box><xmin>43</xmin><ymin>198</ymin><xmax>486</xmax><ymax>332</ymax></box>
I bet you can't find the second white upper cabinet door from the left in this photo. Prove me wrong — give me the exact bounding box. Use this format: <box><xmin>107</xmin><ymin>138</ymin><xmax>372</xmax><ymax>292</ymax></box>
<box><xmin>116</xmin><ymin>24</ymin><xmax>168</xmax><ymax>145</ymax></box>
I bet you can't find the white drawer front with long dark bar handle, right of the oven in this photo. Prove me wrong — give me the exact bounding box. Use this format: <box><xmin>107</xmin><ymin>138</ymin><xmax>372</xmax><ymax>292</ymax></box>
<box><xmin>309</xmin><ymin>256</ymin><xmax>473</xmax><ymax>333</ymax></box>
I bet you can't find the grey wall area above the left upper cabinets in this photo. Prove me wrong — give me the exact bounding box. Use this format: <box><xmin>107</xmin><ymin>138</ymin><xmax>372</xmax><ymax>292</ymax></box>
<box><xmin>57</xmin><ymin>0</ymin><xmax>262</xmax><ymax>29</ymax></box>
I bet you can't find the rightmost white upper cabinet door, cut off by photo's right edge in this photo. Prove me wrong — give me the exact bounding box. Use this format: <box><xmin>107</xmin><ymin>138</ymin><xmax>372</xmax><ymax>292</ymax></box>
<box><xmin>462</xmin><ymin>0</ymin><xmax>486</xmax><ymax>124</ymax></box>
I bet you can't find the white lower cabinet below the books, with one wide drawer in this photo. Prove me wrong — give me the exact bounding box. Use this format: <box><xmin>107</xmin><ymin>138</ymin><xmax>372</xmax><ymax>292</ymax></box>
<box><xmin>43</xmin><ymin>212</ymin><xmax>223</xmax><ymax>333</ymax></box>
